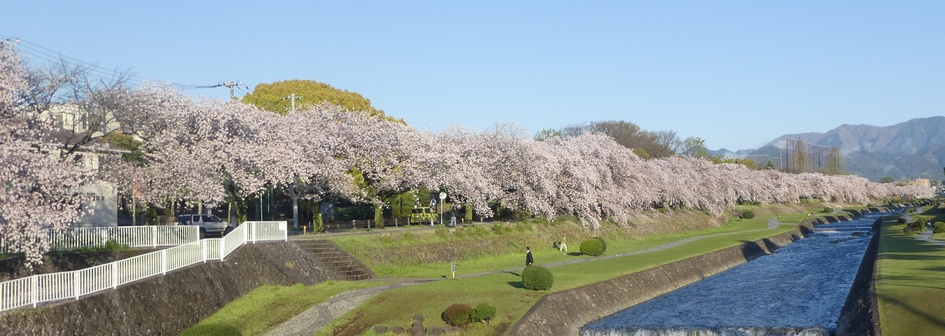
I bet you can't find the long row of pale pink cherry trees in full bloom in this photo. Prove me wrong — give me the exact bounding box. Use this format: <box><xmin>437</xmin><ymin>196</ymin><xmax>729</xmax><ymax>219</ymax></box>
<box><xmin>0</xmin><ymin>43</ymin><xmax>931</xmax><ymax>266</ymax></box>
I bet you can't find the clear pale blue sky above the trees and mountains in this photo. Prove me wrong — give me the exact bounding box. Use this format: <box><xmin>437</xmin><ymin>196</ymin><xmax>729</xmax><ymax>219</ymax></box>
<box><xmin>0</xmin><ymin>1</ymin><xmax>945</xmax><ymax>150</ymax></box>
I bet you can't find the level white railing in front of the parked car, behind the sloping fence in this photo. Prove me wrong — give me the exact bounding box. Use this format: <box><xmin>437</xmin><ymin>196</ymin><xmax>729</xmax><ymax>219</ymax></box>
<box><xmin>0</xmin><ymin>225</ymin><xmax>200</xmax><ymax>253</ymax></box>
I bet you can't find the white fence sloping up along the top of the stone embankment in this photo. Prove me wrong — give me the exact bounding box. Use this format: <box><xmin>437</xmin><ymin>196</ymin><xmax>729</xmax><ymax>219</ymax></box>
<box><xmin>0</xmin><ymin>221</ymin><xmax>288</xmax><ymax>311</ymax></box>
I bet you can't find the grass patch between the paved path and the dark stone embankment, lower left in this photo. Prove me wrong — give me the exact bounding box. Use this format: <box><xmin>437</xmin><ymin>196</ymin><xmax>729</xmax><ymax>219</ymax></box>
<box><xmin>180</xmin><ymin>281</ymin><xmax>382</xmax><ymax>336</ymax></box>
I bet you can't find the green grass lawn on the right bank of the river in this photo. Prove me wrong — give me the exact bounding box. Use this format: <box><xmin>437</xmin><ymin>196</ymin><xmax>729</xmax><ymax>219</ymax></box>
<box><xmin>876</xmin><ymin>215</ymin><xmax>945</xmax><ymax>335</ymax></box>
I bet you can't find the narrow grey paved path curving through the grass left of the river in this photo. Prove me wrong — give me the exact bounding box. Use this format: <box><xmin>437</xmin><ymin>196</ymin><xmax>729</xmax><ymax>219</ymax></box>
<box><xmin>266</xmin><ymin>224</ymin><xmax>780</xmax><ymax>336</ymax></box>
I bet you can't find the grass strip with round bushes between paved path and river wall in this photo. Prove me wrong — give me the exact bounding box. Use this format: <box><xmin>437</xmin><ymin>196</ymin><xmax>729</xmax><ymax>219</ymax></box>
<box><xmin>317</xmin><ymin>216</ymin><xmax>806</xmax><ymax>335</ymax></box>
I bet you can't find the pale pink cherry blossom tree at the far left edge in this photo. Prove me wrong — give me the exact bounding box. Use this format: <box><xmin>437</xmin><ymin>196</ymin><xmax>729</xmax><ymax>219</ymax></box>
<box><xmin>0</xmin><ymin>42</ymin><xmax>93</xmax><ymax>268</ymax></box>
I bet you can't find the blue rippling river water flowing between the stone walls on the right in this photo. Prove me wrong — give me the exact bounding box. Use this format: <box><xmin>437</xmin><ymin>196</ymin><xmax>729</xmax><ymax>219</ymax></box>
<box><xmin>581</xmin><ymin>214</ymin><xmax>883</xmax><ymax>336</ymax></box>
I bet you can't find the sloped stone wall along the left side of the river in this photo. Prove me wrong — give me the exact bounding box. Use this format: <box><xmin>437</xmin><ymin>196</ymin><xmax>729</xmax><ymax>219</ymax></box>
<box><xmin>506</xmin><ymin>216</ymin><xmax>824</xmax><ymax>336</ymax></box>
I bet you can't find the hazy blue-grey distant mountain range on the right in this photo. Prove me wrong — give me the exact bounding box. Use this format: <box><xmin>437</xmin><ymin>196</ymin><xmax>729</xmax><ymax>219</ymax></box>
<box><xmin>710</xmin><ymin>117</ymin><xmax>945</xmax><ymax>181</ymax></box>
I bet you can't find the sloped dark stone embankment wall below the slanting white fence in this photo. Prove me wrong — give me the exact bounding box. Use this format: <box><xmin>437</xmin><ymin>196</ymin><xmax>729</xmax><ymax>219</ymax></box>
<box><xmin>0</xmin><ymin>242</ymin><xmax>334</xmax><ymax>335</ymax></box>
